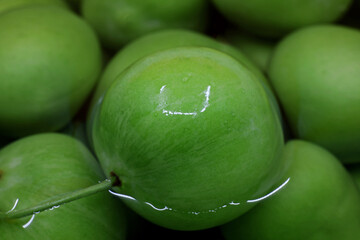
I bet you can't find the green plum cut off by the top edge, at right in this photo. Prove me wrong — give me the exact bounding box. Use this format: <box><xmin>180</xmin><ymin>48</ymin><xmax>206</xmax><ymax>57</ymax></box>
<box><xmin>213</xmin><ymin>0</ymin><xmax>352</xmax><ymax>38</ymax></box>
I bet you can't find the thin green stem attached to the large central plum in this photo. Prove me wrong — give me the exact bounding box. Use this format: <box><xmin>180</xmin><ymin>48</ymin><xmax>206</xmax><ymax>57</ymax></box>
<box><xmin>0</xmin><ymin>176</ymin><xmax>118</xmax><ymax>220</ymax></box>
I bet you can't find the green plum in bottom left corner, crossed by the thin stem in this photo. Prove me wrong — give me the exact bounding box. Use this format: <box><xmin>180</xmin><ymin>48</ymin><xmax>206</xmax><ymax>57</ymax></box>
<box><xmin>0</xmin><ymin>133</ymin><xmax>127</xmax><ymax>240</ymax></box>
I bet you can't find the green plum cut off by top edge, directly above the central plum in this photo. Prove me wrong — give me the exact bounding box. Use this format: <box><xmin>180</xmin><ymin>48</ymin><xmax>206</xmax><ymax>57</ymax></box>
<box><xmin>81</xmin><ymin>0</ymin><xmax>208</xmax><ymax>49</ymax></box>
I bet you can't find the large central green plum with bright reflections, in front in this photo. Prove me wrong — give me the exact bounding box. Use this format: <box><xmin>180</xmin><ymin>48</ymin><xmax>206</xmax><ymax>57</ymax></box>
<box><xmin>92</xmin><ymin>47</ymin><xmax>283</xmax><ymax>230</ymax></box>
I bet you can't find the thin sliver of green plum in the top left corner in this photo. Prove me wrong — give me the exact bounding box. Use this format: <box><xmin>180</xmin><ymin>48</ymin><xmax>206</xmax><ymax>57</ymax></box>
<box><xmin>0</xmin><ymin>0</ymin><xmax>67</xmax><ymax>14</ymax></box>
